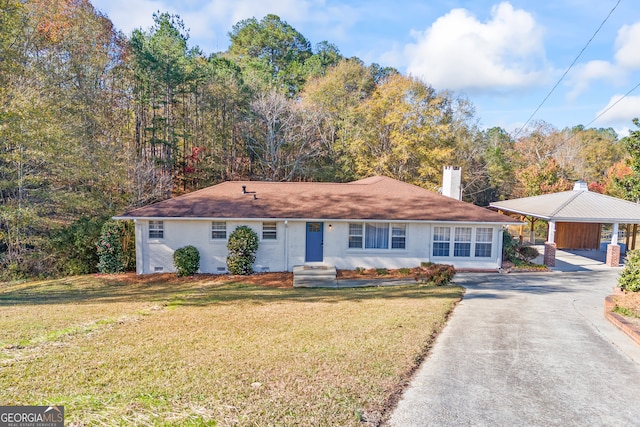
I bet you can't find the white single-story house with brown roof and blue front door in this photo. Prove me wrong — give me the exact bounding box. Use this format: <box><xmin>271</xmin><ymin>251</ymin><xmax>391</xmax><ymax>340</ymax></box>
<box><xmin>116</xmin><ymin>176</ymin><xmax>520</xmax><ymax>274</ymax></box>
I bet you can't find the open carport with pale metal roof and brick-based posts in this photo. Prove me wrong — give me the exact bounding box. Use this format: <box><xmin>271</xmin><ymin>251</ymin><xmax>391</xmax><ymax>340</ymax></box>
<box><xmin>490</xmin><ymin>181</ymin><xmax>640</xmax><ymax>267</ymax></box>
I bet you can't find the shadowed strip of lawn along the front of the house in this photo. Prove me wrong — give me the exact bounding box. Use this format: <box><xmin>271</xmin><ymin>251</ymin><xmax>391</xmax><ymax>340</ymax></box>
<box><xmin>0</xmin><ymin>275</ymin><xmax>463</xmax><ymax>306</ymax></box>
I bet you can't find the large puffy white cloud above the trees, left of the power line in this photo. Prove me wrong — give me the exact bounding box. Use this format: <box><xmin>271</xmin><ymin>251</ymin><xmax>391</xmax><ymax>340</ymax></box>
<box><xmin>404</xmin><ymin>2</ymin><xmax>547</xmax><ymax>92</ymax></box>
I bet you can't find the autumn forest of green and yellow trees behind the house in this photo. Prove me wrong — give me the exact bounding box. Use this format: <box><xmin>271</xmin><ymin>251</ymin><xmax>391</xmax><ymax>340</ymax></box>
<box><xmin>0</xmin><ymin>0</ymin><xmax>640</xmax><ymax>278</ymax></box>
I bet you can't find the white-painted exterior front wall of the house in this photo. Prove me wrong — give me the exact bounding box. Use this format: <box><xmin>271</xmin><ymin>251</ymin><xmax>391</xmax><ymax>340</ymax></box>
<box><xmin>136</xmin><ymin>220</ymin><xmax>502</xmax><ymax>274</ymax></box>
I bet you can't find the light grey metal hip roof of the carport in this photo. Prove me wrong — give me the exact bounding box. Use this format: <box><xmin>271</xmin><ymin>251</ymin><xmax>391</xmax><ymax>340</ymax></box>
<box><xmin>490</xmin><ymin>185</ymin><xmax>640</xmax><ymax>224</ymax></box>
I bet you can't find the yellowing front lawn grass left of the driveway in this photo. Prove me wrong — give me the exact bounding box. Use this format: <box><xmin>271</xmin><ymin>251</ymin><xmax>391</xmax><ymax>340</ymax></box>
<box><xmin>0</xmin><ymin>275</ymin><xmax>463</xmax><ymax>426</ymax></box>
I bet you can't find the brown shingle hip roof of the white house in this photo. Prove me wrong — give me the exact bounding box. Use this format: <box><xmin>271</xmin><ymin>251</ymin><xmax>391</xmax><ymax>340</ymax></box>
<box><xmin>118</xmin><ymin>176</ymin><xmax>517</xmax><ymax>224</ymax></box>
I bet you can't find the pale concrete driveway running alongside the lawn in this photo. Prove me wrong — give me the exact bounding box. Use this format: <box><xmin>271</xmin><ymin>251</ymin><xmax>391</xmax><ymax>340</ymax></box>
<box><xmin>389</xmin><ymin>269</ymin><xmax>640</xmax><ymax>426</ymax></box>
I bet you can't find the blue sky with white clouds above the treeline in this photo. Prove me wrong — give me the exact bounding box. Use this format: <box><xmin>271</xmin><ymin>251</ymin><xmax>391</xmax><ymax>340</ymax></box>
<box><xmin>92</xmin><ymin>0</ymin><xmax>640</xmax><ymax>135</ymax></box>
